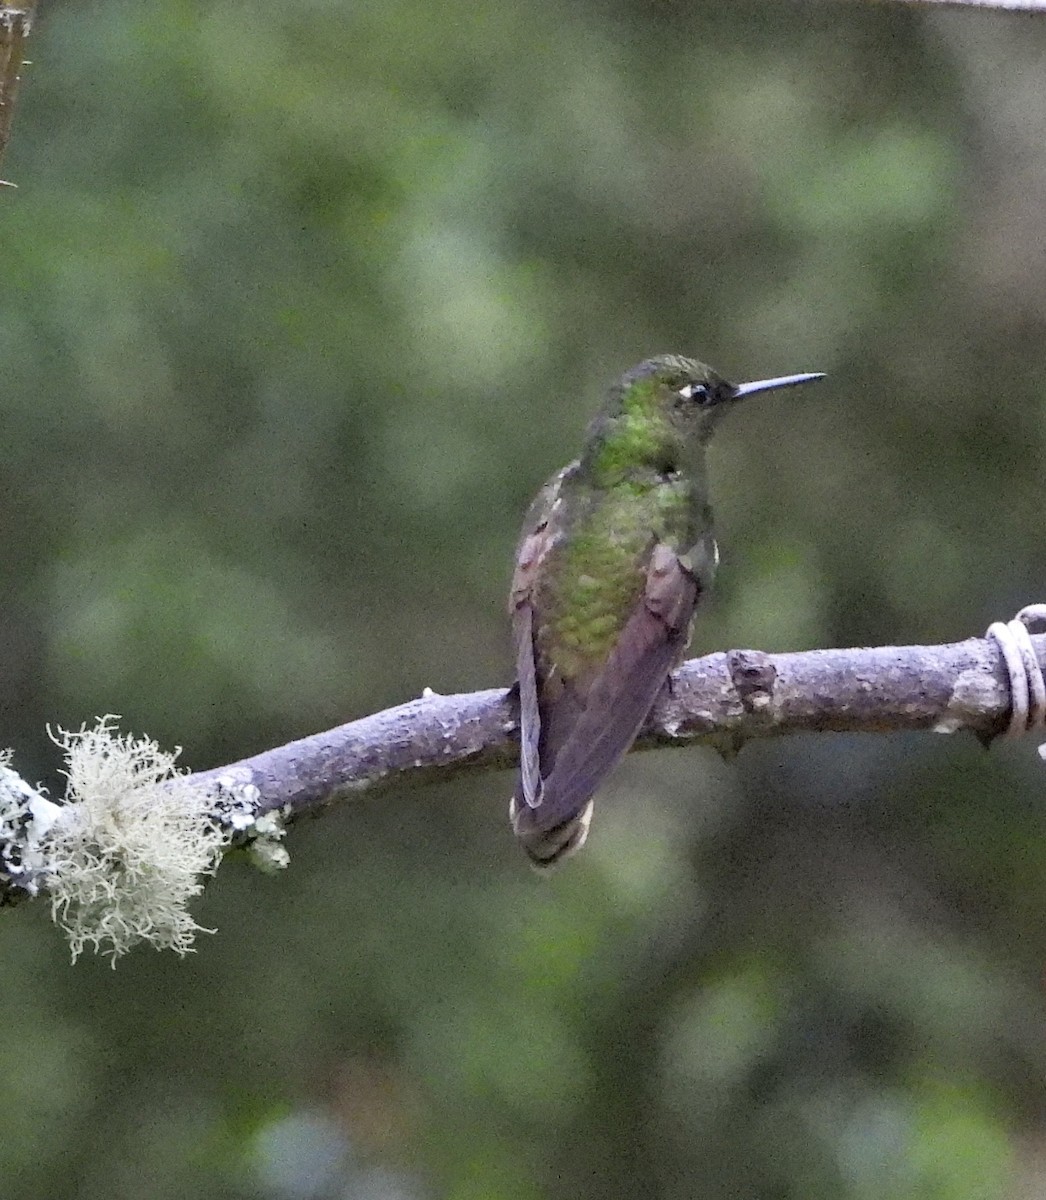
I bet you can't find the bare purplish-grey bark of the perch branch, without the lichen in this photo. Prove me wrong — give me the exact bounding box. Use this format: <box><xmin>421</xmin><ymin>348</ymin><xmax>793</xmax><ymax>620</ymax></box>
<box><xmin>188</xmin><ymin>635</ymin><xmax>1046</xmax><ymax>817</ymax></box>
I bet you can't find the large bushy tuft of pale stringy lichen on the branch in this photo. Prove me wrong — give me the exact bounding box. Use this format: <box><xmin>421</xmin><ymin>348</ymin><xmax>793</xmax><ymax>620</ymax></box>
<box><xmin>47</xmin><ymin>718</ymin><xmax>228</xmax><ymax>965</ymax></box>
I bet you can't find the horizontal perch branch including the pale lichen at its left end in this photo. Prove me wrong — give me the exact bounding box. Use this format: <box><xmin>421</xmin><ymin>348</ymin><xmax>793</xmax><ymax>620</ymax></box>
<box><xmin>0</xmin><ymin>633</ymin><xmax>1046</xmax><ymax>962</ymax></box>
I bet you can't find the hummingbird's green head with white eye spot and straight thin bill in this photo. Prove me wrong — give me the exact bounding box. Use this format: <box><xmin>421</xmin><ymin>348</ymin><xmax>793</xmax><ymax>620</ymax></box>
<box><xmin>611</xmin><ymin>354</ymin><xmax>824</xmax><ymax>443</ymax></box>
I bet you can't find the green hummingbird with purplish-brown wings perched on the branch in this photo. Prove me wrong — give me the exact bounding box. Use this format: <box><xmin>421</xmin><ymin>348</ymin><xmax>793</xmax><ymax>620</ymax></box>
<box><xmin>509</xmin><ymin>354</ymin><xmax>824</xmax><ymax>870</ymax></box>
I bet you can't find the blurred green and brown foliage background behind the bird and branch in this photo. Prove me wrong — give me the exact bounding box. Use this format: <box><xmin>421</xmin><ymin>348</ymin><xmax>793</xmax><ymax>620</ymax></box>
<box><xmin>0</xmin><ymin>0</ymin><xmax>1046</xmax><ymax>1200</ymax></box>
